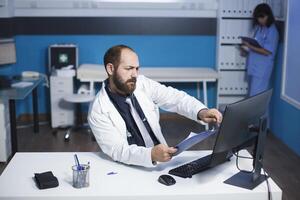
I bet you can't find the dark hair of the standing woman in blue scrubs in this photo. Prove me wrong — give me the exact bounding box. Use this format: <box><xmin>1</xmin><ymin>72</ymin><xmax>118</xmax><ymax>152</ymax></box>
<box><xmin>253</xmin><ymin>3</ymin><xmax>275</xmax><ymax>27</ymax></box>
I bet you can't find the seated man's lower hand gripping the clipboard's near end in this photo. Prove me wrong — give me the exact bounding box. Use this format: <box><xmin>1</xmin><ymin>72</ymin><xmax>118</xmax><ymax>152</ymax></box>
<box><xmin>151</xmin><ymin>144</ymin><xmax>177</xmax><ymax>162</ymax></box>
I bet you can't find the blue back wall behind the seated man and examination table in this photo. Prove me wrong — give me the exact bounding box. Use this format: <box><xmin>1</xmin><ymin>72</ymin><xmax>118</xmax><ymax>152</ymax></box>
<box><xmin>0</xmin><ymin>35</ymin><xmax>216</xmax><ymax>114</ymax></box>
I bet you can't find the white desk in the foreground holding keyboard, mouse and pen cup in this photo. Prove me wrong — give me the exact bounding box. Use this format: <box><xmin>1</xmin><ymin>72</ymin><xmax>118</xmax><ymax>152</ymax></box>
<box><xmin>0</xmin><ymin>151</ymin><xmax>282</xmax><ymax>200</ymax></box>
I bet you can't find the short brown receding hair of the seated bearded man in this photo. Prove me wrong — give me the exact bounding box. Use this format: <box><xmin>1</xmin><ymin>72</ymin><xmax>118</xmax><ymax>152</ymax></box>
<box><xmin>103</xmin><ymin>44</ymin><xmax>135</xmax><ymax>69</ymax></box>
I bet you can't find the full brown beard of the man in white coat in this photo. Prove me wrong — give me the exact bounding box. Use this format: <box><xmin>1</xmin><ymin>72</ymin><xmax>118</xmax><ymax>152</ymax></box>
<box><xmin>112</xmin><ymin>74</ymin><xmax>136</xmax><ymax>95</ymax></box>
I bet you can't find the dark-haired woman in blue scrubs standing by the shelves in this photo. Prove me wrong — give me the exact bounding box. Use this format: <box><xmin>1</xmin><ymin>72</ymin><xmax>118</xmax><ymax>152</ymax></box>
<box><xmin>242</xmin><ymin>3</ymin><xmax>279</xmax><ymax>96</ymax></box>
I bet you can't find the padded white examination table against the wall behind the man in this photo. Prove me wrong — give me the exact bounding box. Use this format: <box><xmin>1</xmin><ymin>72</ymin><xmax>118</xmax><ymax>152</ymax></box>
<box><xmin>77</xmin><ymin>64</ymin><xmax>219</xmax><ymax>106</ymax></box>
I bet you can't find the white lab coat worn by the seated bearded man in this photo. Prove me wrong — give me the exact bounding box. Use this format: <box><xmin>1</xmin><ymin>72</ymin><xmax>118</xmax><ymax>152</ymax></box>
<box><xmin>88</xmin><ymin>75</ymin><xmax>206</xmax><ymax>167</ymax></box>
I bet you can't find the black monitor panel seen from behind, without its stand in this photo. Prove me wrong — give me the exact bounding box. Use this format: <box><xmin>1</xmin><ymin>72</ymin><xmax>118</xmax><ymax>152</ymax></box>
<box><xmin>214</xmin><ymin>90</ymin><xmax>272</xmax><ymax>153</ymax></box>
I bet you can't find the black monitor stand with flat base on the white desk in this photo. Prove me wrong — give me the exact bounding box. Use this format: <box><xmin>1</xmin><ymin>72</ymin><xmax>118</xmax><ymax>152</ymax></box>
<box><xmin>224</xmin><ymin>117</ymin><xmax>268</xmax><ymax>190</ymax></box>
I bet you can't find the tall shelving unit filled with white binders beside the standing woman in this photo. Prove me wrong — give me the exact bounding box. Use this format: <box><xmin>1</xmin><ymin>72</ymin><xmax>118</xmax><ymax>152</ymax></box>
<box><xmin>216</xmin><ymin>0</ymin><xmax>264</xmax><ymax>110</ymax></box>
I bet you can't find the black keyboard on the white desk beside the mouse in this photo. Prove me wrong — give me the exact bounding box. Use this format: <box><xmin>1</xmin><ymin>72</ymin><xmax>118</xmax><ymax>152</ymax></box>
<box><xmin>169</xmin><ymin>154</ymin><xmax>212</xmax><ymax>178</ymax></box>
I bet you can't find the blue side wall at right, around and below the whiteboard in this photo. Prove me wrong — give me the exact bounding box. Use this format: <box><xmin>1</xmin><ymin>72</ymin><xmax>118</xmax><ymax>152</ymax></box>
<box><xmin>270</xmin><ymin>44</ymin><xmax>300</xmax><ymax>155</ymax></box>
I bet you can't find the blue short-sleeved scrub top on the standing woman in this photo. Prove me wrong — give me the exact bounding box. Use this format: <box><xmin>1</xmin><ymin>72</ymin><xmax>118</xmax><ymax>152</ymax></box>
<box><xmin>247</xmin><ymin>24</ymin><xmax>279</xmax><ymax>79</ymax></box>
